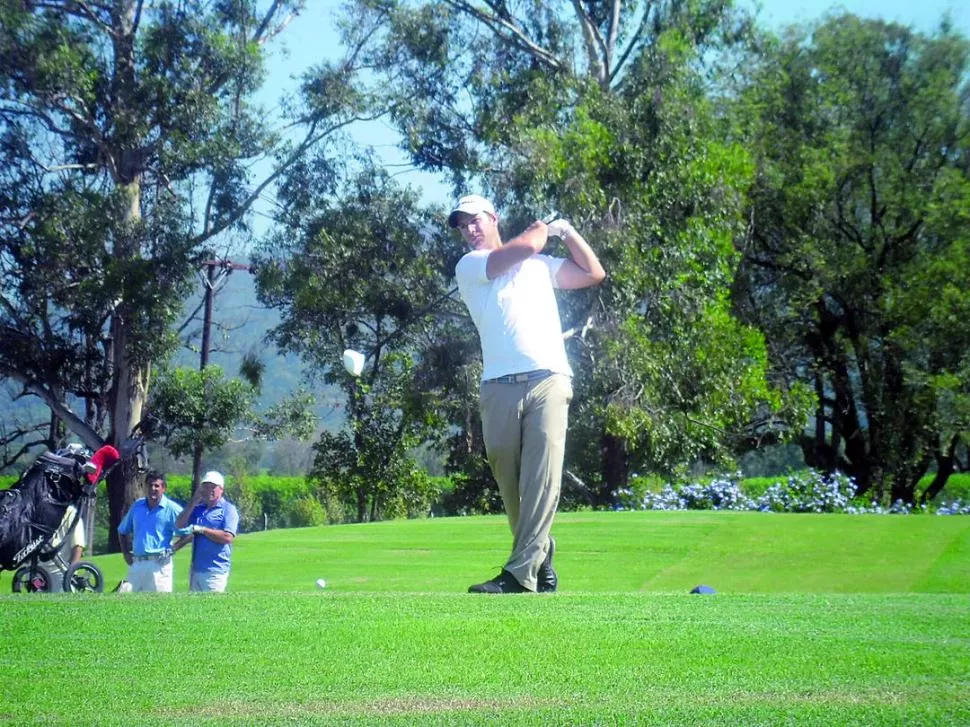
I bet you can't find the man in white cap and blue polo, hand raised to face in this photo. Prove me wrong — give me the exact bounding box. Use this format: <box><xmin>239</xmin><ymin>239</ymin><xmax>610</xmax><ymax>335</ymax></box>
<box><xmin>177</xmin><ymin>472</ymin><xmax>239</xmax><ymax>592</ymax></box>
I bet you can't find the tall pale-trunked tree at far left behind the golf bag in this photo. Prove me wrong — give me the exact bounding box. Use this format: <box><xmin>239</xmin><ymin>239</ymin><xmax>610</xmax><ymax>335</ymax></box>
<box><xmin>0</xmin><ymin>0</ymin><xmax>368</xmax><ymax>544</ymax></box>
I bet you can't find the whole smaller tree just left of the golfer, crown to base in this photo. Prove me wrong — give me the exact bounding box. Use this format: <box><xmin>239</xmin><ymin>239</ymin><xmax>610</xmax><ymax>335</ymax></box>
<box><xmin>258</xmin><ymin>165</ymin><xmax>451</xmax><ymax>521</ymax></box>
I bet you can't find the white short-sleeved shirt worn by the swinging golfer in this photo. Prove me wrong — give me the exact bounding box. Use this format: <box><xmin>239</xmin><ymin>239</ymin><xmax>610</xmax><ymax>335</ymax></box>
<box><xmin>455</xmin><ymin>250</ymin><xmax>573</xmax><ymax>381</ymax></box>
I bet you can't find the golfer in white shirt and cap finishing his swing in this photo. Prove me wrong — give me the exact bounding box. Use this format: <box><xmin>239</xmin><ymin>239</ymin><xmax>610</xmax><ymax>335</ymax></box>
<box><xmin>448</xmin><ymin>195</ymin><xmax>606</xmax><ymax>593</ymax></box>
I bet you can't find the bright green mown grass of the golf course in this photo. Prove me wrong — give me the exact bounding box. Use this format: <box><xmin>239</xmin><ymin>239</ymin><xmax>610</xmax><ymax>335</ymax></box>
<box><xmin>0</xmin><ymin>512</ymin><xmax>970</xmax><ymax>725</ymax></box>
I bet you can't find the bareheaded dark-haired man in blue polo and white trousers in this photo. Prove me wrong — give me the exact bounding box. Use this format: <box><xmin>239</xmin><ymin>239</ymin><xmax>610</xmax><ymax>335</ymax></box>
<box><xmin>118</xmin><ymin>472</ymin><xmax>188</xmax><ymax>593</ymax></box>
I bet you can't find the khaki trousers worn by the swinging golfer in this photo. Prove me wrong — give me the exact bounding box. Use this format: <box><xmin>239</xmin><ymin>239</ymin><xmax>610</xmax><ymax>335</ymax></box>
<box><xmin>481</xmin><ymin>374</ymin><xmax>573</xmax><ymax>591</ymax></box>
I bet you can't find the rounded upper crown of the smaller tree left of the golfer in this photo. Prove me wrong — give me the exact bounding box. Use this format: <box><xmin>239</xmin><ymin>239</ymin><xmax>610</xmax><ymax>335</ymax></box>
<box><xmin>254</xmin><ymin>160</ymin><xmax>453</xmax><ymax>382</ymax></box>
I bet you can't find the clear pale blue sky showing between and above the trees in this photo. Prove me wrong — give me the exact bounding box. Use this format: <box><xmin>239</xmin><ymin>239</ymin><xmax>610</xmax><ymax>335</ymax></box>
<box><xmin>263</xmin><ymin>0</ymin><xmax>970</xmax><ymax>208</ymax></box>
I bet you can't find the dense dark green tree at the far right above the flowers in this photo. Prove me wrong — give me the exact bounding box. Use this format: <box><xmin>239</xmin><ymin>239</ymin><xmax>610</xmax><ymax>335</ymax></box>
<box><xmin>739</xmin><ymin>15</ymin><xmax>970</xmax><ymax>502</ymax></box>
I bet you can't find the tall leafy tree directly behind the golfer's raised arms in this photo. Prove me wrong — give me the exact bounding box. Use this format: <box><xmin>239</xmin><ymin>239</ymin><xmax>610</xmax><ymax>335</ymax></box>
<box><xmin>332</xmin><ymin>0</ymin><xmax>806</xmax><ymax>502</ymax></box>
